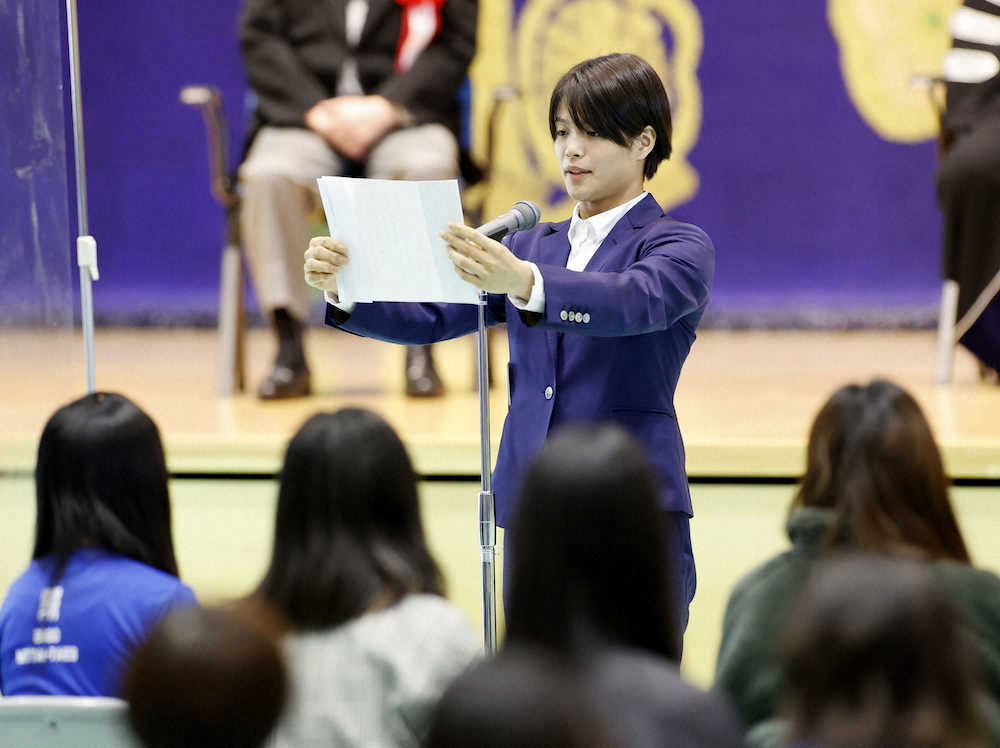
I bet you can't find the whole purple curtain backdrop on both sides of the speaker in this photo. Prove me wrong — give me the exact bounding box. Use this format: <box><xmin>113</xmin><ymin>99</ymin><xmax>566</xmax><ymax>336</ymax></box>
<box><xmin>79</xmin><ymin>0</ymin><xmax>940</xmax><ymax>326</ymax></box>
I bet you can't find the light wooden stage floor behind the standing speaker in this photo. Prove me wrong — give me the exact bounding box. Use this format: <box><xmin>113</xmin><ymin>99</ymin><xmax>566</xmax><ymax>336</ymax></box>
<box><xmin>0</xmin><ymin>328</ymin><xmax>1000</xmax><ymax>480</ymax></box>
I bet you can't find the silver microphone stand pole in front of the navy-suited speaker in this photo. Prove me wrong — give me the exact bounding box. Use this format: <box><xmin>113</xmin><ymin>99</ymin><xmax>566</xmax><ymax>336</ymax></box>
<box><xmin>477</xmin><ymin>291</ymin><xmax>497</xmax><ymax>655</ymax></box>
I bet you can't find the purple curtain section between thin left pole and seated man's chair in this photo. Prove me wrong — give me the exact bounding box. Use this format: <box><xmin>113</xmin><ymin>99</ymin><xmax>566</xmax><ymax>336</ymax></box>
<box><xmin>78</xmin><ymin>0</ymin><xmax>247</xmax><ymax>323</ymax></box>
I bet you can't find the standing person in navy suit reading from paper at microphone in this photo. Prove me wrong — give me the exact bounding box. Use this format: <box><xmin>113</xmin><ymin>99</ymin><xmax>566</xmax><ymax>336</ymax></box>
<box><xmin>305</xmin><ymin>54</ymin><xmax>715</xmax><ymax>636</ymax></box>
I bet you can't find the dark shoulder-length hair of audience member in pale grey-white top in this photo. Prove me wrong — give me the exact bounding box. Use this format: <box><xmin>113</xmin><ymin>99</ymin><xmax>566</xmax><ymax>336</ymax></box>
<box><xmin>258</xmin><ymin>408</ymin><xmax>442</xmax><ymax>630</ymax></box>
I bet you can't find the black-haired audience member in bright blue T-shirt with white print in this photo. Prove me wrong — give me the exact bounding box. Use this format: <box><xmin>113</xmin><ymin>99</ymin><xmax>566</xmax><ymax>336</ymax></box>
<box><xmin>0</xmin><ymin>392</ymin><xmax>195</xmax><ymax>696</ymax></box>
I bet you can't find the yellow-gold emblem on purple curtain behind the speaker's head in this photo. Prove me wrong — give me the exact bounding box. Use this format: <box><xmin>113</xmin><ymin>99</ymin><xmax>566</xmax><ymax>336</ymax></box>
<box><xmin>472</xmin><ymin>0</ymin><xmax>703</xmax><ymax>220</ymax></box>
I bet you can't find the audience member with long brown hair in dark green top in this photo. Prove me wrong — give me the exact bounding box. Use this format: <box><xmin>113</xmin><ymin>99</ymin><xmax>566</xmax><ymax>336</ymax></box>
<box><xmin>715</xmin><ymin>380</ymin><xmax>1000</xmax><ymax>740</ymax></box>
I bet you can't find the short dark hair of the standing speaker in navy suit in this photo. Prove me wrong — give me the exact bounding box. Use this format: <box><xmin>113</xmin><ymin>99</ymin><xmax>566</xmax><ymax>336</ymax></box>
<box><xmin>549</xmin><ymin>54</ymin><xmax>673</xmax><ymax>179</ymax></box>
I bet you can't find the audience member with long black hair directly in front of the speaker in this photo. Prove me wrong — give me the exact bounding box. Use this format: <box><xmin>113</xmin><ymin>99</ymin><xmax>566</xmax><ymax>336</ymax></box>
<box><xmin>499</xmin><ymin>425</ymin><xmax>743</xmax><ymax>748</ymax></box>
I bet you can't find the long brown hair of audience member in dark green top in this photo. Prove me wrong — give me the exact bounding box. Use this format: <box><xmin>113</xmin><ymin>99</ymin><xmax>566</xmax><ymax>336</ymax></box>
<box><xmin>792</xmin><ymin>380</ymin><xmax>969</xmax><ymax>562</ymax></box>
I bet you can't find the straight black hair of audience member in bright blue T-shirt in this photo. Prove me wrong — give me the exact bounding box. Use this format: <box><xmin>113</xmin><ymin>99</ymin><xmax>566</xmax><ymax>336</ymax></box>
<box><xmin>32</xmin><ymin>392</ymin><xmax>177</xmax><ymax>581</ymax></box>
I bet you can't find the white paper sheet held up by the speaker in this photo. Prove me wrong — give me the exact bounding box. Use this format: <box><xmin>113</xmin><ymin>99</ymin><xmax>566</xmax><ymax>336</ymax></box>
<box><xmin>317</xmin><ymin>177</ymin><xmax>479</xmax><ymax>304</ymax></box>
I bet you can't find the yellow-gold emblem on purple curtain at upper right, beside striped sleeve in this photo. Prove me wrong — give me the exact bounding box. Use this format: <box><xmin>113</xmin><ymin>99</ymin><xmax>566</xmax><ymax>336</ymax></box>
<box><xmin>827</xmin><ymin>0</ymin><xmax>961</xmax><ymax>143</ymax></box>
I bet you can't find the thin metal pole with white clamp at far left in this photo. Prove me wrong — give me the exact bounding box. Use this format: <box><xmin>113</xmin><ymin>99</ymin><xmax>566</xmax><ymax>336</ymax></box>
<box><xmin>66</xmin><ymin>0</ymin><xmax>99</xmax><ymax>393</ymax></box>
